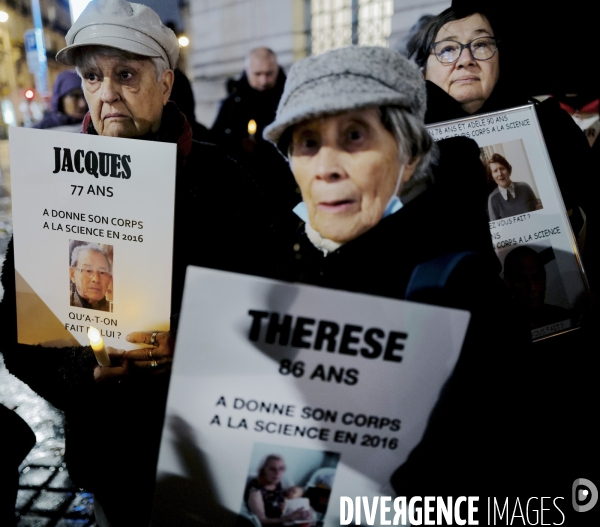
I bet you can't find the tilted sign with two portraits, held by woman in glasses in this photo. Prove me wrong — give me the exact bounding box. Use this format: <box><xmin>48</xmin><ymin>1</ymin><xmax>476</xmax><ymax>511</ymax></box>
<box><xmin>427</xmin><ymin>105</ymin><xmax>588</xmax><ymax>340</ymax></box>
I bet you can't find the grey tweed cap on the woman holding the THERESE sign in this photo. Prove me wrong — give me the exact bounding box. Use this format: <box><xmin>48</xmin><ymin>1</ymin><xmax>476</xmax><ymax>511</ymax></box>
<box><xmin>263</xmin><ymin>46</ymin><xmax>427</xmax><ymax>154</ymax></box>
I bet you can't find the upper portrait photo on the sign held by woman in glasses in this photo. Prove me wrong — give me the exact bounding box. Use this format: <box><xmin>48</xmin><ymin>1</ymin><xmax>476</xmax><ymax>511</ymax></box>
<box><xmin>481</xmin><ymin>139</ymin><xmax>543</xmax><ymax>221</ymax></box>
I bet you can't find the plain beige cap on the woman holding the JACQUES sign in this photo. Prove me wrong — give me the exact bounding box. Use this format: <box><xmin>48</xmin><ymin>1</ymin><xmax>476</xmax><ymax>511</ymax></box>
<box><xmin>56</xmin><ymin>0</ymin><xmax>179</xmax><ymax>69</ymax></box>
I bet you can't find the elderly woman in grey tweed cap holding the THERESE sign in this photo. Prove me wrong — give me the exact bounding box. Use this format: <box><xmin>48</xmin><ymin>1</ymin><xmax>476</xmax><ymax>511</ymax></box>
<box><xmin>264</xmin><ymin>46</ymin><xmax>529</xmax><ymax>496</ymax></box>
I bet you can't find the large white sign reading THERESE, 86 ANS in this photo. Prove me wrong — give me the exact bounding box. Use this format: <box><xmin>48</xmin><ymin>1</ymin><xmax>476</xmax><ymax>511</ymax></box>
<box><xmin>153</xmin><ymin>267</ymin><xmax>469</xmax><ymax>527</ymax></box>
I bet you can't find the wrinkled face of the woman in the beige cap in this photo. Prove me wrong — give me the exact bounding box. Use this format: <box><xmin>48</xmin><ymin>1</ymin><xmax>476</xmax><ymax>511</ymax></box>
<box><xmin>81</xmin><ymin>57</ymin><xmax>173</xmax><ymax>138</ymax></box>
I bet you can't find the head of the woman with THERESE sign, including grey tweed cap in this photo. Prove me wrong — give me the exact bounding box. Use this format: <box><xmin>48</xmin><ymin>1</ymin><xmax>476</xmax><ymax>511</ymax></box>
<box><xmin>265</xmin><ymin>47</ymin><xmax>434</xmax><ymax>252</ymax></box>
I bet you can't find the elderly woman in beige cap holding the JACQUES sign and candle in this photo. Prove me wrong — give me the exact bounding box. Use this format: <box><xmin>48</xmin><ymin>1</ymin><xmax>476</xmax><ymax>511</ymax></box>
<box><xmin>0</xmin><ymin>0</ymin><xmax>276</xmax><ymax>527</ymax></box>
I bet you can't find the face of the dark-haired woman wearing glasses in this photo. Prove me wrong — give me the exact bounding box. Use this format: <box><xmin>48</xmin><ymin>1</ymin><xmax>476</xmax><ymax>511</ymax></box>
<box><xmin>425</xmin><ymin>14</ymin><xmax>500</xmax><ymax>113</ymax></box>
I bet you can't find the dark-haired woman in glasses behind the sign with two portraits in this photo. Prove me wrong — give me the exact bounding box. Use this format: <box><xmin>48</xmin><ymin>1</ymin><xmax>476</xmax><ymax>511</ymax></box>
<box><xmin>406</xmin><ymin>7</ymin><xmax>597</xmax><ymax>261</ymax></box>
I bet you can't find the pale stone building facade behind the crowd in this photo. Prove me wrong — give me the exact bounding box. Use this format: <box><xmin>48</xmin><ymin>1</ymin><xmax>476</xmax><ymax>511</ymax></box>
<box><xmin>185</xmin><ymin>0</ymin><xmax>450</xmax><ymax>127</ymax></box>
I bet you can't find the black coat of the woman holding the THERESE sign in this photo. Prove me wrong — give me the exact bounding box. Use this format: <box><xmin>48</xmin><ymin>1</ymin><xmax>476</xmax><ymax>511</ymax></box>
<box><xmin>282</xmin><ymin>138</ymin><xmax>530</xmax><ymax>496</ymax></box>
